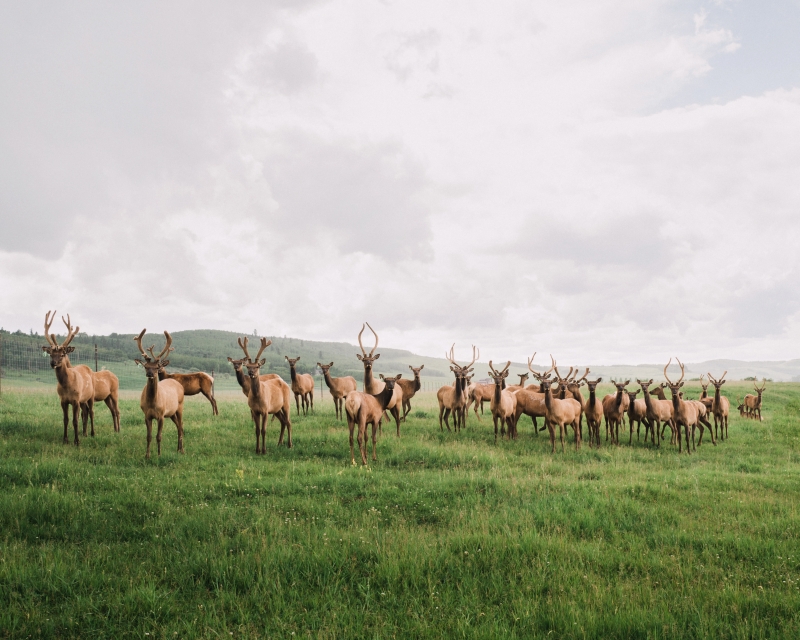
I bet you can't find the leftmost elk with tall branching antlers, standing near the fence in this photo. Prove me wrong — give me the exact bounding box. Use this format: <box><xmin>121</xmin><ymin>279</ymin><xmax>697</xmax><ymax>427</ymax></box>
<box><xmin>42</xmin><ymin>311</ymin><xmax>94</xmax><ymax>446</ymax></box>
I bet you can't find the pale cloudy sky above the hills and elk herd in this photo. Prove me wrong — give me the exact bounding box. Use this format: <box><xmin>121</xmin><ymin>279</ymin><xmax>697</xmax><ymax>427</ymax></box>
<box><xmin>0</xmin><ymin>0</ymin><xmax>800</xmax><ymax>364</ymax></box>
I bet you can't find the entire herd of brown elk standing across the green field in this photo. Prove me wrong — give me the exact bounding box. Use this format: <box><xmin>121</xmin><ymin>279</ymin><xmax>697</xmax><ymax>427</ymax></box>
<box><xmin>42</xmin><ymin>311</ymin><xmax>766</xmax><ymax>464</ymax></box>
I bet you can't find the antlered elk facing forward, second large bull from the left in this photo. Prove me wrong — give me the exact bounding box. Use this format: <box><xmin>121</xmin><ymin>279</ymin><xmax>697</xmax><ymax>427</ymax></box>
<box><xmin>133</xmin><ymin>329</ymin><xmax>184</xmax><ymax>458</ymax></box>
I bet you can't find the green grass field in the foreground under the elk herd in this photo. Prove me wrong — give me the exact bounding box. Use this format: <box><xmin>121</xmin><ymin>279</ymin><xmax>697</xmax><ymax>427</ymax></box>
<box><xmin>0</xmin><ymin>383</ymin><xmax>800</xmax><ymax>639</ymax></box>
